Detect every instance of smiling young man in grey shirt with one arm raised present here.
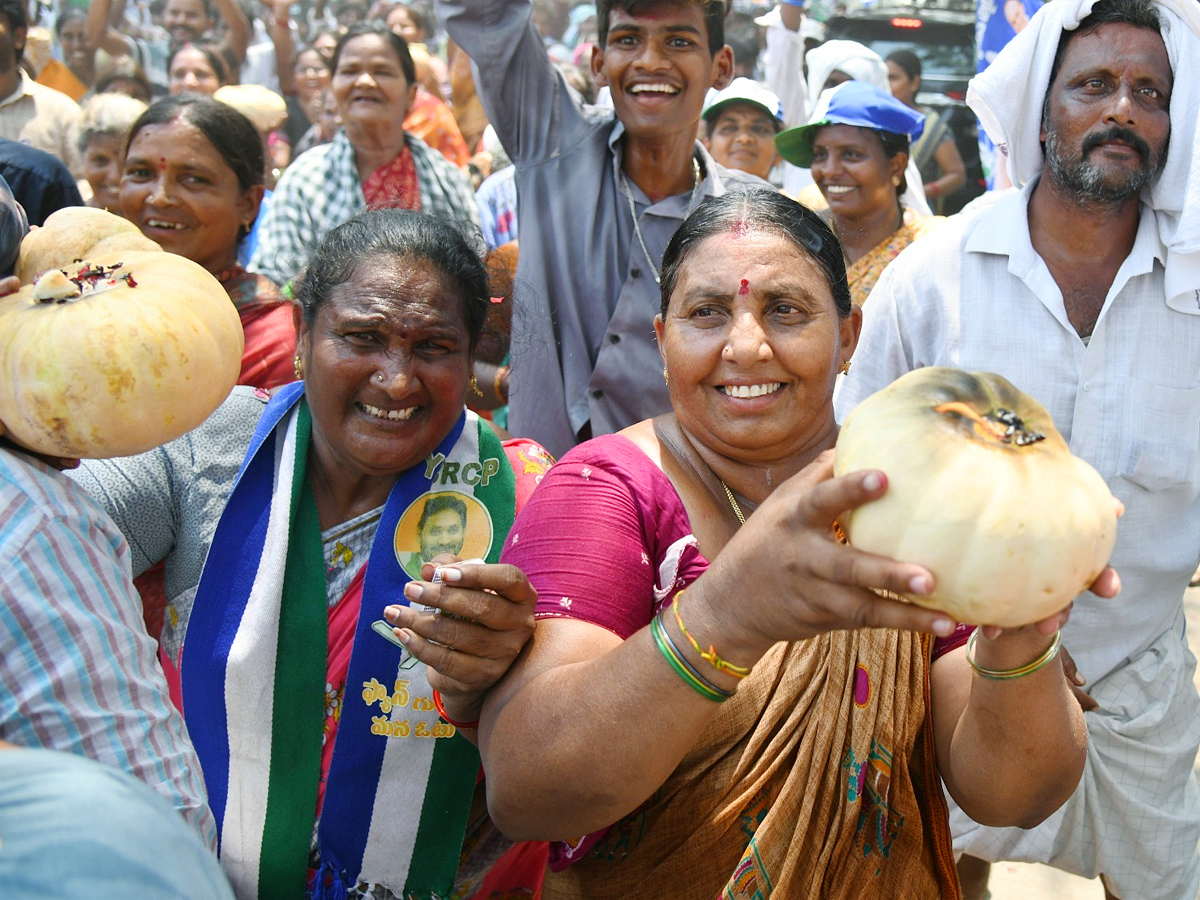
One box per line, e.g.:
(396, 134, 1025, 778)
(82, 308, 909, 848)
(439, 0, 762, 455)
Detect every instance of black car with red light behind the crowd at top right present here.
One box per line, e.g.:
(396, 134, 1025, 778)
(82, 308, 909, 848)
(826, 0, 984, 215)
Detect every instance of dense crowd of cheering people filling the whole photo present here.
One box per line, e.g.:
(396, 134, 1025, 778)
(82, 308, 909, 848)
(0, 0, 1200, 900)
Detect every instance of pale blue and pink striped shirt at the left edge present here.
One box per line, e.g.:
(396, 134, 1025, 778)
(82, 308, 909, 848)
(0, 448, 216, 847)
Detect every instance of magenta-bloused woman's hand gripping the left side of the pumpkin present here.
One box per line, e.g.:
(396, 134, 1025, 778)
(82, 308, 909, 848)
(689, 450, 955, 659)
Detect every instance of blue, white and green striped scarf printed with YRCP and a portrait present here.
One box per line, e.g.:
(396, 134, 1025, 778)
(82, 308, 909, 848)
(182, 383, 516, 900)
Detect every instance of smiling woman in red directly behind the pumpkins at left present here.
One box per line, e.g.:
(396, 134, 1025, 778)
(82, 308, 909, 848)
(120, 95, 295, 388)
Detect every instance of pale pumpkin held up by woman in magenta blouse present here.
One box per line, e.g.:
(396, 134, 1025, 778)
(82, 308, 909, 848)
(834, 367, 1117, 626)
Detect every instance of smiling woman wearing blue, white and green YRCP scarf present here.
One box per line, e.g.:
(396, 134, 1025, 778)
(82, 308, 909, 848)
(70, 211, 548, 900)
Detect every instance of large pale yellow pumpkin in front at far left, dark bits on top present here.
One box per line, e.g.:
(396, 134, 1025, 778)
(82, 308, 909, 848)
(0, 251, 244, 457)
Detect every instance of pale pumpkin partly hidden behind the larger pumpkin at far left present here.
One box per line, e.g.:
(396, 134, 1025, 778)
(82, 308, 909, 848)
(14, 206, 162, 284)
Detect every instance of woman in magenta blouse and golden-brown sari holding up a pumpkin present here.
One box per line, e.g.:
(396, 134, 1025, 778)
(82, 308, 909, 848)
(480, 191, 1115, 899)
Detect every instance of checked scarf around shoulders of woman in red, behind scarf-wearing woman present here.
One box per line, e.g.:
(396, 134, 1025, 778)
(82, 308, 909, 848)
(247, 131, 479, 284)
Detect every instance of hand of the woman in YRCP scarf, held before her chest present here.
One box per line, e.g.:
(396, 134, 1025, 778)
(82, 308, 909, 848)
(384, 557, 538, 719)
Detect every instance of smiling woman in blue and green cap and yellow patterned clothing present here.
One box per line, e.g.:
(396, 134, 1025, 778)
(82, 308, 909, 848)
(775, 82, 942, 306)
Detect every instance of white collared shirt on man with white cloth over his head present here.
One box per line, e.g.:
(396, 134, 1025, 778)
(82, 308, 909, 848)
(836, 182, 1200, 680)
